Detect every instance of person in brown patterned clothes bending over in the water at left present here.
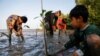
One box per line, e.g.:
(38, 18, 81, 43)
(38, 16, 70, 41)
(7, 15, 27, 44)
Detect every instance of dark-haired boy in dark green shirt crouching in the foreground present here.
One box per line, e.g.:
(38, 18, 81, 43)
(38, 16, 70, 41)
(52, 5, 100, 56)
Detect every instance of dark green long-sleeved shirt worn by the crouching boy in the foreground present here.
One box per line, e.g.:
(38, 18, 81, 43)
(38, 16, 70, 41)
(65, 25, 100, 56)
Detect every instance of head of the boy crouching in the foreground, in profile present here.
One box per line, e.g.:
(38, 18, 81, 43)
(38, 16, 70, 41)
(69, 5, 89, 28)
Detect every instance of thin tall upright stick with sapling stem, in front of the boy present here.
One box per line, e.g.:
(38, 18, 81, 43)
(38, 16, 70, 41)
(41, 0, 48, 56)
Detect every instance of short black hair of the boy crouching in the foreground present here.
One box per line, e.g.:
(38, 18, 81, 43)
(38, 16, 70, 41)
(69, 5, 89, 22)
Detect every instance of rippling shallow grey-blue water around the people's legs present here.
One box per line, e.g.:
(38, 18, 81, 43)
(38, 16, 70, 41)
(0, 30, 70, 56)
